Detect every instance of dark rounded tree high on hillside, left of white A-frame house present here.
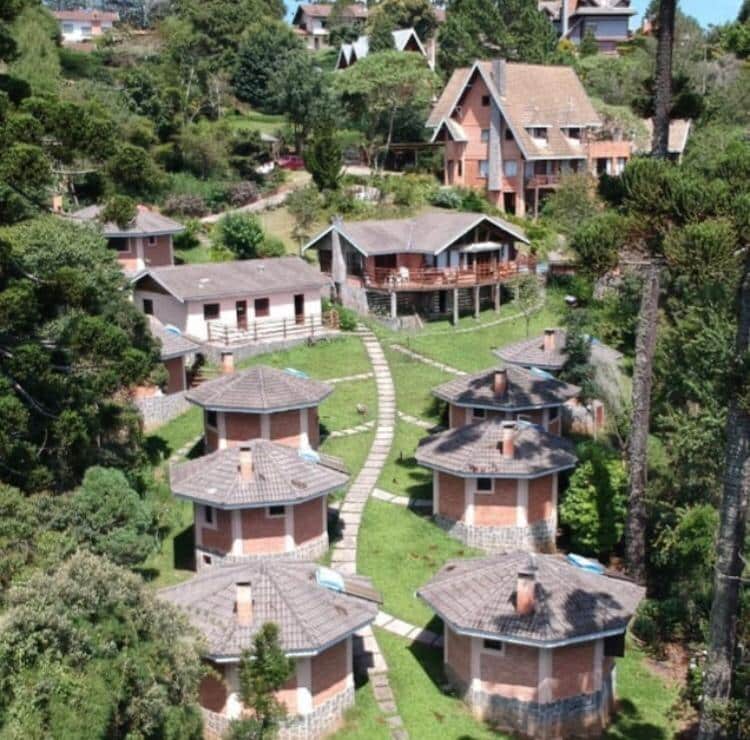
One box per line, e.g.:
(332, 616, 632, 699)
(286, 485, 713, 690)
(232, 22, 303, 113)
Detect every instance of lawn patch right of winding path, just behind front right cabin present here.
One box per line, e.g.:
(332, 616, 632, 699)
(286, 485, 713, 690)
(357, 499, 478, 625)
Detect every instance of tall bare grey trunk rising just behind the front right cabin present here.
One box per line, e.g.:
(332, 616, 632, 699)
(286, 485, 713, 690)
(625, 263, 660, 584)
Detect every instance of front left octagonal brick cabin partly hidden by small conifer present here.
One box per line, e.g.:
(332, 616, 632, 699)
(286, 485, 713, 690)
(159, 560, 379, 740)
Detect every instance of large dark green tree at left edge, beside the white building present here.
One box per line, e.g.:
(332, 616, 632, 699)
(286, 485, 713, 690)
(0, 217, 158, 491)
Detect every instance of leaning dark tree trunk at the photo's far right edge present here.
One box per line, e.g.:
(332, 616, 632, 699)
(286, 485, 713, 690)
(698, 254, 750, 740)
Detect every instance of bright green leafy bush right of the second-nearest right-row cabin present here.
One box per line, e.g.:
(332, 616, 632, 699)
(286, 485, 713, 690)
(560, 442, 628, 558)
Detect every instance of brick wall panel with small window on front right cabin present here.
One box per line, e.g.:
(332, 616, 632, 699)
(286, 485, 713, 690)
(479, 643, 539, 701)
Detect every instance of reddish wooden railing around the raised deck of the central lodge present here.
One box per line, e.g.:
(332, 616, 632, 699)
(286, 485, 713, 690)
(364, 256, 536, 291)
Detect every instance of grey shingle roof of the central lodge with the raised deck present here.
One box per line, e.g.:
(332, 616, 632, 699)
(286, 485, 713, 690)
(305, 211, 528, 255)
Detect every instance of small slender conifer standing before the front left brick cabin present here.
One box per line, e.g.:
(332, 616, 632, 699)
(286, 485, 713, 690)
(229, 622, 295, 740)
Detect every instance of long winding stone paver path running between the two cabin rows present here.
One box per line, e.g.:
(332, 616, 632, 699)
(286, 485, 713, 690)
(331, 327, 409, 740)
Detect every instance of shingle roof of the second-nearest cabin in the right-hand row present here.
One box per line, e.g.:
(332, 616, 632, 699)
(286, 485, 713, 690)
(415, 419, 577, 478)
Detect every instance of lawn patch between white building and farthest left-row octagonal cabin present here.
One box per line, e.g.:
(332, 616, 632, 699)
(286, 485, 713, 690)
(237, 336, 372, 380)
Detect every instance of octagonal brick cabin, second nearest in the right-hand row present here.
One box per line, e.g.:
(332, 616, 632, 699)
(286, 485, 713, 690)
(415, 419, 576, 551)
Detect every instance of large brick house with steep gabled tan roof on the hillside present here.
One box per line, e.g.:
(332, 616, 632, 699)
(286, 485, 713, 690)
(427, 59, 632, 216)
